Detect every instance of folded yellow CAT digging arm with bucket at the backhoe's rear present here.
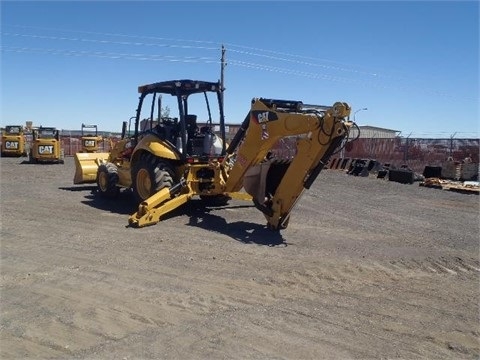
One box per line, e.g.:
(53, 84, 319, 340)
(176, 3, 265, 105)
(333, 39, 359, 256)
(224, 98, 352, 230)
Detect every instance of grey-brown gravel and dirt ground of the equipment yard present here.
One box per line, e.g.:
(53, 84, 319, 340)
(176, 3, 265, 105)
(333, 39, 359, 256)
(0, 158, 480, 360)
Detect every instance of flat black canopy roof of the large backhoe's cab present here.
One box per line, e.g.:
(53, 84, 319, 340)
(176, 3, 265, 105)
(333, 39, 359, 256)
(138, 79, 220, 95)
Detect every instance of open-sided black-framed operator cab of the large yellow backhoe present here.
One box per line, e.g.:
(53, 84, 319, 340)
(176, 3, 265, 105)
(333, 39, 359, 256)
(136, 80, 225, 159)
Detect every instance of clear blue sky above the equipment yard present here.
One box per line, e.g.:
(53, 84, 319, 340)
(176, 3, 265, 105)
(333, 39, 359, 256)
(0, 1, 479, 138)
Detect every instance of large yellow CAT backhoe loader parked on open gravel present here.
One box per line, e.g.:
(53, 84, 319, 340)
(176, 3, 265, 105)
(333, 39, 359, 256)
(75, 80, 353, 230)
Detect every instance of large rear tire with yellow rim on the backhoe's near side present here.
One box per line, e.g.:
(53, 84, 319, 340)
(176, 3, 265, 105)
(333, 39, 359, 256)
(132, 153, 175, 204)
